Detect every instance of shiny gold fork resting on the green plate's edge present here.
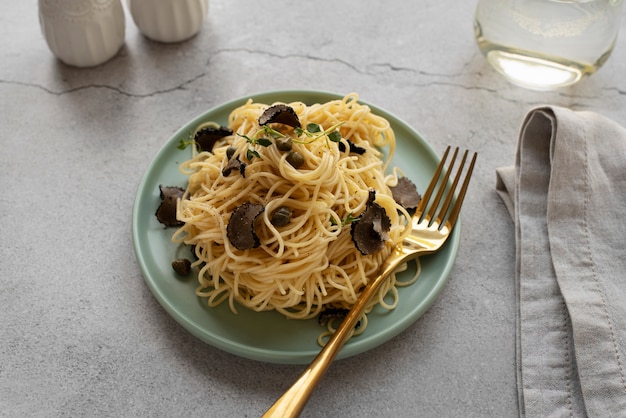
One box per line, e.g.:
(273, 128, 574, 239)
(263, 146, 476, 418)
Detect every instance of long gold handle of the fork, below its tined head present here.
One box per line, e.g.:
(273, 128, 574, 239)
(263, 257, 399, 418)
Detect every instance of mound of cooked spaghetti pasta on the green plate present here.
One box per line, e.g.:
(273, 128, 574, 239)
(173, 94, 418, 338)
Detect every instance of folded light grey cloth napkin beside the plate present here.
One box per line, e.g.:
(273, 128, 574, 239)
(496, 106, 626, 417)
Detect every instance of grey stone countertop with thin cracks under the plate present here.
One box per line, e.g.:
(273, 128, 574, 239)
(0, 0, 626, 417)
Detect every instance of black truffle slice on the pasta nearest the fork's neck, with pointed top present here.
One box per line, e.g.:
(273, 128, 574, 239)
(350, 192, 391, 255)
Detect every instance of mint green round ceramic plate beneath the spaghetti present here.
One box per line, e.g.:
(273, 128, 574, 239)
(132, 91, 460, 364)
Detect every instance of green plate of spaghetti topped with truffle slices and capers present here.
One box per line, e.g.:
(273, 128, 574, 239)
(132, 91, 460, 364)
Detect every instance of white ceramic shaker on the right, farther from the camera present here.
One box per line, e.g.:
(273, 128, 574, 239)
(128, 0, 209, 42)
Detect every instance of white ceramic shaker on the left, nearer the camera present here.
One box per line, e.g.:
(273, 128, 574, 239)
(39, 0, 126, 67)
